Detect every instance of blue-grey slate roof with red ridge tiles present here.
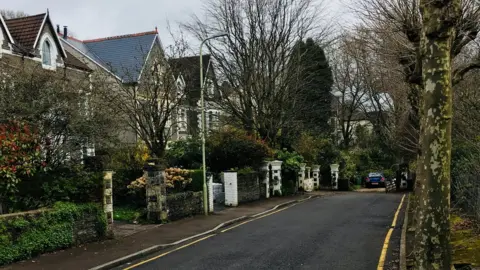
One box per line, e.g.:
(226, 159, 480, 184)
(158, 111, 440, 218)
(62, 31, 159, 83)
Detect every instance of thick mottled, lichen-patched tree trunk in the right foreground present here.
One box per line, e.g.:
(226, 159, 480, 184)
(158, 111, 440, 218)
(415, 0, 461, 270)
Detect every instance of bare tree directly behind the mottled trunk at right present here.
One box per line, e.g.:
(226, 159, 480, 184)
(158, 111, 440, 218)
(355, 0, 480, 154)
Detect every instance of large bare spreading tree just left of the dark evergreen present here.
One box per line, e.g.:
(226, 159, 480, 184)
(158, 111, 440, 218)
(185, 0, 334, 144)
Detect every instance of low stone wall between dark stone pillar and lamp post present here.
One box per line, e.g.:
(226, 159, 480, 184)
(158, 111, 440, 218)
(167, 191, 203, 221)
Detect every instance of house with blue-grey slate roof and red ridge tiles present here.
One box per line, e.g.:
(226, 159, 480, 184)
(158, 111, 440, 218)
(57, 28, 188, 146)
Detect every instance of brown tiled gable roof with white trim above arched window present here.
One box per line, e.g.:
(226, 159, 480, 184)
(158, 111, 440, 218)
(5, 13, 67, 58)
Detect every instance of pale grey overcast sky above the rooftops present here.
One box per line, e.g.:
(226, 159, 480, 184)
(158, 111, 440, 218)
(0, 0, 352, 47)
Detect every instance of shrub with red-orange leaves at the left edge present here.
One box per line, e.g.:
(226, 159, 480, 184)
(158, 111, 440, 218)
(0, 121, 42, 195)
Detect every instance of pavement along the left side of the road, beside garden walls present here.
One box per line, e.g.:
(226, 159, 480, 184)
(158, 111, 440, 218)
(1, 192, 334, 270)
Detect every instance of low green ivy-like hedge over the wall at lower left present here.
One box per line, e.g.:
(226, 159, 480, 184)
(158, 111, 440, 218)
(0, 203, 107, 265)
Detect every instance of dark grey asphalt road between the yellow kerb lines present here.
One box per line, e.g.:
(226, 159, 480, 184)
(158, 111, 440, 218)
(123, 193, 402, 270)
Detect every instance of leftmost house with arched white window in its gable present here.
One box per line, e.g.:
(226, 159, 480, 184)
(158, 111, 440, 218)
(0, 12, 94, 160)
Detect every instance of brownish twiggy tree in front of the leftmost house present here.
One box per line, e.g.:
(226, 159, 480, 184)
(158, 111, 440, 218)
(0, 61, 116, 167)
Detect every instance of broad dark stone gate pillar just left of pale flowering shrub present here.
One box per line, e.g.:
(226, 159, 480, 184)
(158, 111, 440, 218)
(144, 163, 168, 222)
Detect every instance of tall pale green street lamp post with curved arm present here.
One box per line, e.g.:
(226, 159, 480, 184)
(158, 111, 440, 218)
(200, 33, 227, 216)
